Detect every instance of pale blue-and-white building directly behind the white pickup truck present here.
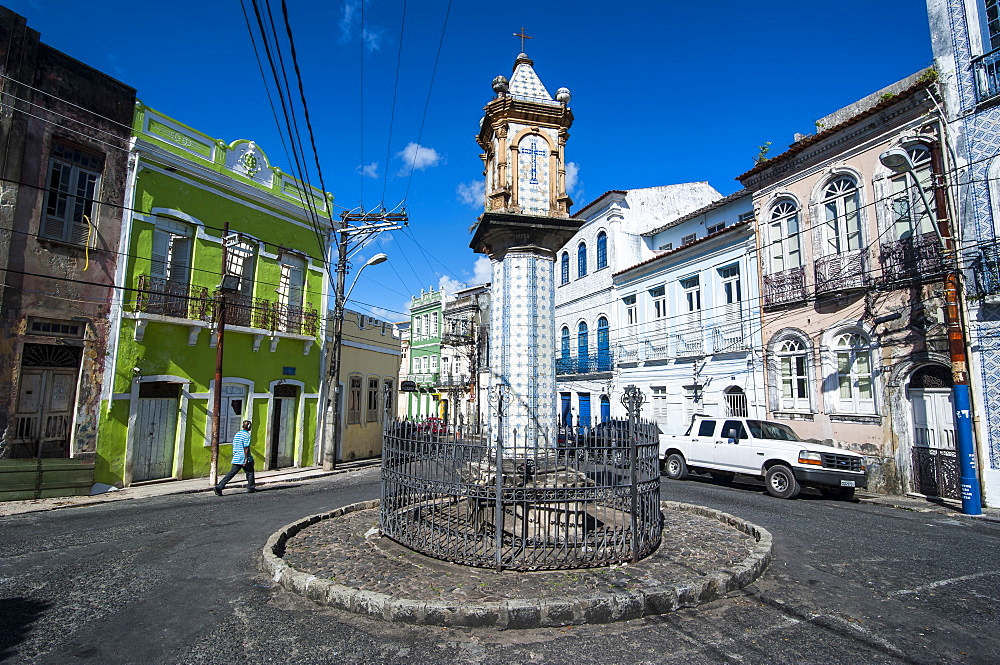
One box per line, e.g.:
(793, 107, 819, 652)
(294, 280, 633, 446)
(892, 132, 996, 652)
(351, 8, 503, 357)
(613, 190, 766, 434)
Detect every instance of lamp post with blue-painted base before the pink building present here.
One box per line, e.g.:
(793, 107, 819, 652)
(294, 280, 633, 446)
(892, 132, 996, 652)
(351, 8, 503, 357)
(879, 144, 983, 515)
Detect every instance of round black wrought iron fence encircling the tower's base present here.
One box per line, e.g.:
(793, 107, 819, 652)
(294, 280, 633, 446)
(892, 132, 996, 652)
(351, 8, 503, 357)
(380, 387, 663, 570)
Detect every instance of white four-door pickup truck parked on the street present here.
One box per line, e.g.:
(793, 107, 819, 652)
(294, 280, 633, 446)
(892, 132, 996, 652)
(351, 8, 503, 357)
(660, 416, 868, 499)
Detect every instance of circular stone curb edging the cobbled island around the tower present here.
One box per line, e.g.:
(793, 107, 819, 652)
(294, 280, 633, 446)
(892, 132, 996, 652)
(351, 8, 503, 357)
(263, 499, 772, 629)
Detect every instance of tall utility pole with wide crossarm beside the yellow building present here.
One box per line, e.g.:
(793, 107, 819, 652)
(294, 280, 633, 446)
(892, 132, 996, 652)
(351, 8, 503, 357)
(323, 209, 408, 471)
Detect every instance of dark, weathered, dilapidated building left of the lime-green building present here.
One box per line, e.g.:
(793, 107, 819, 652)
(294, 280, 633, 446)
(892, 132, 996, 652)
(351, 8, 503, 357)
(0, 7, 135, 498)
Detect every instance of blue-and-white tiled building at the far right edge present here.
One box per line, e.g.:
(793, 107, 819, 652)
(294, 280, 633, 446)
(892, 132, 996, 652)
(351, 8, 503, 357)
(927, 0, 1000, 506)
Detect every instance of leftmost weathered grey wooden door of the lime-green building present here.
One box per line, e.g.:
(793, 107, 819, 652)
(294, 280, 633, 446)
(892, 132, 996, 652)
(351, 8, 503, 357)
(132, 397, 178, 482)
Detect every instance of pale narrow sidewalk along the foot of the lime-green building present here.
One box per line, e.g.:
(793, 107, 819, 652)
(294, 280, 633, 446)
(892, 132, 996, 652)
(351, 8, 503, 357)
(0, 458, 382, 517)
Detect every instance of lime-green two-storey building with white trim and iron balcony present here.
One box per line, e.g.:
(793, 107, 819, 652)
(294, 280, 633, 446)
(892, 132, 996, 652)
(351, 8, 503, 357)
(95, 103, 332, 486)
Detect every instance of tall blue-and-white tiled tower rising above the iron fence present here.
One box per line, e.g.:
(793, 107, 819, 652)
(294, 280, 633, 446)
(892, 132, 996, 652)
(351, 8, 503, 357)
(471, 53, 582, 446)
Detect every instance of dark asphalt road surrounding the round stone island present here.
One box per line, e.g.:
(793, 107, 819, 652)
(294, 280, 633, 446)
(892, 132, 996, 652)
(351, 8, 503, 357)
(0, 468, 1000, 665)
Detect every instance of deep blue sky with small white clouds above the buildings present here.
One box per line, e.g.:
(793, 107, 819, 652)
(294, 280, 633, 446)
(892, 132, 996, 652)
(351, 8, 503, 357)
(0, 0, 932, 320)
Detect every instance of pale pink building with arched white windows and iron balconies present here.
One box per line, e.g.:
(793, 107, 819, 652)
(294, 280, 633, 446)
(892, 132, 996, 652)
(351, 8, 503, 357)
(739, 71, 957, 495)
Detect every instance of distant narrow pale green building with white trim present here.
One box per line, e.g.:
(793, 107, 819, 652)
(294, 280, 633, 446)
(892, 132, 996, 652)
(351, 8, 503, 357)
(406, 291, 444, 418)
